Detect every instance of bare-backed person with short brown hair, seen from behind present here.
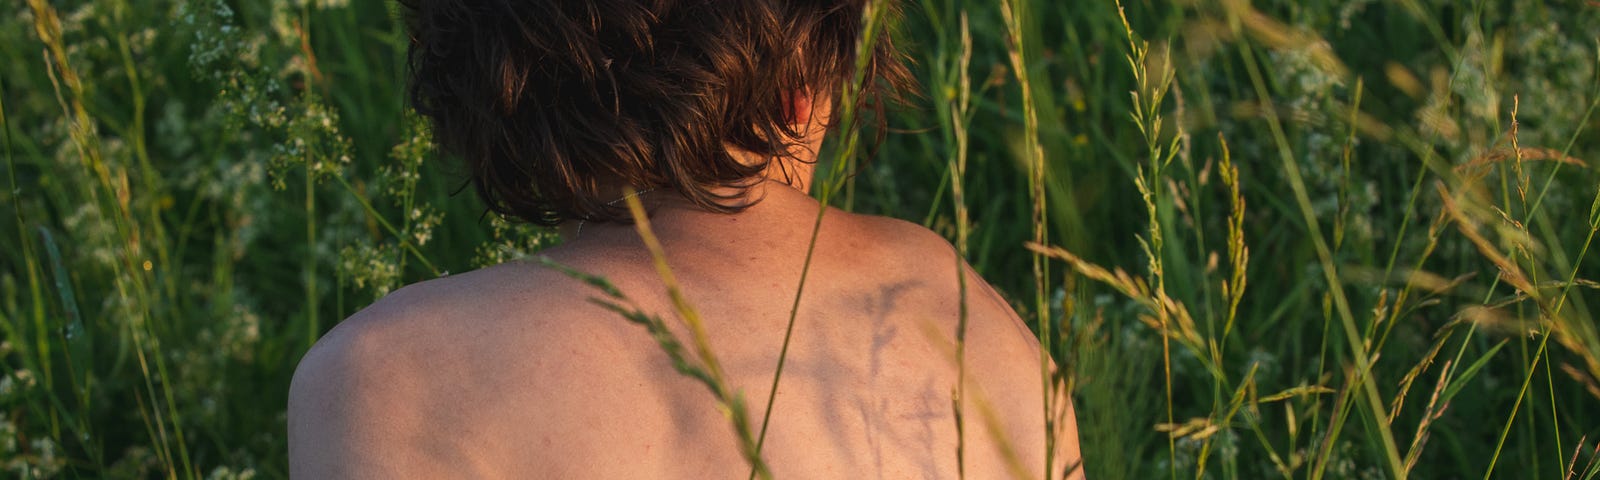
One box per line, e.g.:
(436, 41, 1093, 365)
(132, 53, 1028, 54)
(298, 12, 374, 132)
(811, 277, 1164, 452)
(290, 0, 1077, 478)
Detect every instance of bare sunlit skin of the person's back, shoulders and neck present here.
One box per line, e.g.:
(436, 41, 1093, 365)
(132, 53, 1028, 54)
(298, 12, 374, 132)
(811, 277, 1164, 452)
(288, 98, 1078, 478)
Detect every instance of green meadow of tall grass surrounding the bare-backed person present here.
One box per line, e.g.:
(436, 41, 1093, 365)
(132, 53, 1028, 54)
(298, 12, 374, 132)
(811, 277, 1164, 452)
(0, 0, 1600, 478)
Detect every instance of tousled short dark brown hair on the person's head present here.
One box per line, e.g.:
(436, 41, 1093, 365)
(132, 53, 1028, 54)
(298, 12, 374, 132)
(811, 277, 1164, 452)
(400, 0, 909, 226)
